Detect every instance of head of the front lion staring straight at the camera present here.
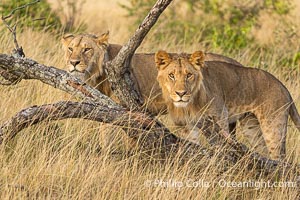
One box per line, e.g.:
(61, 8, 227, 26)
(155, 51, 204, 107)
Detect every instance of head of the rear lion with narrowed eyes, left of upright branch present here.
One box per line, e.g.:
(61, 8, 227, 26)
(62, 33, 108, 82)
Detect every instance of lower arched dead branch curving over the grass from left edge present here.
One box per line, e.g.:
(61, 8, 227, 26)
(0, 101, 213, 158)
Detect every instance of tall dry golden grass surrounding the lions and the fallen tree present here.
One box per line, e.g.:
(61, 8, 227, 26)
(0, 0, 300, 199)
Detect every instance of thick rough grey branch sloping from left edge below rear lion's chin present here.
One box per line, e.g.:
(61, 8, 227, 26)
(0, 54, 121, 107)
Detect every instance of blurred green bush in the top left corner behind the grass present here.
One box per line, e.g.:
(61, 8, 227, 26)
(0, 0, 86, 33)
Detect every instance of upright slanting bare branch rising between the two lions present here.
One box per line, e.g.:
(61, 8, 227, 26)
(106, 0, 172, 109)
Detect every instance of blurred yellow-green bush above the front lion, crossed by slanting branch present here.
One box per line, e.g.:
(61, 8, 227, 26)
(123, 0, 291, 50)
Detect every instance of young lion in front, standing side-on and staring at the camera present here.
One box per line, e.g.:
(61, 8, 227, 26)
(155, 51, 300, 159)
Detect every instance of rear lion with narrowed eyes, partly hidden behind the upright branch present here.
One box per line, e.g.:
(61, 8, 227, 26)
(62, 32, 240, 114)
